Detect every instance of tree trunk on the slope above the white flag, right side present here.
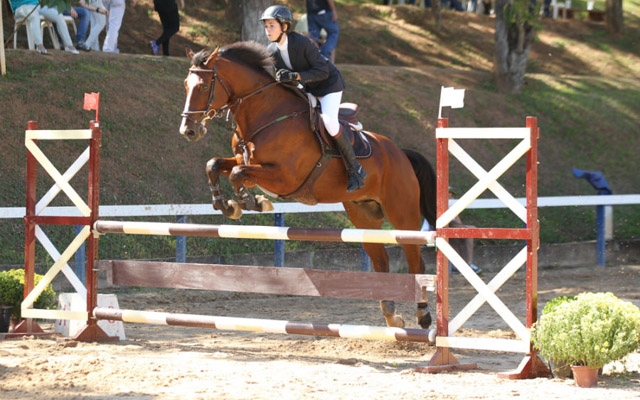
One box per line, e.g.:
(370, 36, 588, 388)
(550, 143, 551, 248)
(493, 0, 533, 94)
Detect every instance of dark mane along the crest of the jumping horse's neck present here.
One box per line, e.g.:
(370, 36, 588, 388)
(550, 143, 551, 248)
(191, 41, 275, 75)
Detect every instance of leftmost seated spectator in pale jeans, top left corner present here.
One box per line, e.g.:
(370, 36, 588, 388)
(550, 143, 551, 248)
(9, 0, 80, 54)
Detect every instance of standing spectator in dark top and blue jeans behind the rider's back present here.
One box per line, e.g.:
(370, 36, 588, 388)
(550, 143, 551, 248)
(307, 0, 340, 61)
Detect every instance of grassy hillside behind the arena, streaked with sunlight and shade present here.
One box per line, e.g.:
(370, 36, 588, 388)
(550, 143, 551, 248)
(0, 0, 640, 263)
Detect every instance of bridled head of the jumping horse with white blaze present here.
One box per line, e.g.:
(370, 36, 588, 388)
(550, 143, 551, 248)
(180, 48, 230, 141)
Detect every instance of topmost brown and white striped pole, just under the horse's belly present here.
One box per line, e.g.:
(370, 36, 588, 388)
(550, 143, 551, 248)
(93, 220, 436, 246)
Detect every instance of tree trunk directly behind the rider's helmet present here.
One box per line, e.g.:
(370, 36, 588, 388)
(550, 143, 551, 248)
(225, 0, 273, 45)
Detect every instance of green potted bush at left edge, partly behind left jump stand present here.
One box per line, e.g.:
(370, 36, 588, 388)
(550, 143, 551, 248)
(0, 268, 56, 328)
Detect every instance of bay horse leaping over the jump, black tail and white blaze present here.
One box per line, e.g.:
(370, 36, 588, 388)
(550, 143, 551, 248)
(180, 42, 436, 329)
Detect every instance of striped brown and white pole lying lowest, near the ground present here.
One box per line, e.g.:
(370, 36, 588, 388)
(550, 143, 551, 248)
(93, 307, 435, 343)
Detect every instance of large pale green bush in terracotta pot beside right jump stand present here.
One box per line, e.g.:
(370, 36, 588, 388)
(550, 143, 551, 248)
(531, 293, 640, 387)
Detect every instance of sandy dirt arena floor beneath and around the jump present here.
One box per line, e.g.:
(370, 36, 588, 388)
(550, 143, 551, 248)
(0, 265, 640, 399)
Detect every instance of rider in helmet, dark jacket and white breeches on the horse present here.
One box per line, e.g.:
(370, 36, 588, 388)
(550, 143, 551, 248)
(260, 5, 367, 192)
